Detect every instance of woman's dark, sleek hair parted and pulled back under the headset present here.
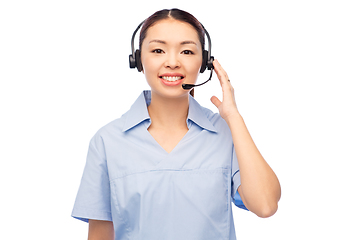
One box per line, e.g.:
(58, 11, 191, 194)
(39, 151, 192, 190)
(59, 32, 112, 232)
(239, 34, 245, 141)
(139, 8, 205, 96)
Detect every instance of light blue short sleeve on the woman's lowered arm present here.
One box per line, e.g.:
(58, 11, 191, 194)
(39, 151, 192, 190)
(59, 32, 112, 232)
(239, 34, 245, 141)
(72, 134, 112, 222)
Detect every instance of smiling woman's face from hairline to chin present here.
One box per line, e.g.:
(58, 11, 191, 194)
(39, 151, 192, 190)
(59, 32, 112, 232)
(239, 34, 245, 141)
(141, 19, 202, 98)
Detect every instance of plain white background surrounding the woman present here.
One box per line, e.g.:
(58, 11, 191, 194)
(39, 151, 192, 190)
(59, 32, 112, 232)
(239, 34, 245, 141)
(0, 0, 348, 240)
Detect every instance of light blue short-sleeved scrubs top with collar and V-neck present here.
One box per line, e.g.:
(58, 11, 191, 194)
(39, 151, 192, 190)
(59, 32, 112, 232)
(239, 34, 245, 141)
(72, 91, 245, 240)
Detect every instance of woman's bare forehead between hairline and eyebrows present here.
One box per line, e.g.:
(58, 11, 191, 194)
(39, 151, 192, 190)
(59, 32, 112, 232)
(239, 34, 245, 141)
(144, 19, 200, 45)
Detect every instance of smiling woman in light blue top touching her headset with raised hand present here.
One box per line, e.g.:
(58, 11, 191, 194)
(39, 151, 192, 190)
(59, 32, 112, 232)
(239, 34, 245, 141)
(72, 9, 280, 240)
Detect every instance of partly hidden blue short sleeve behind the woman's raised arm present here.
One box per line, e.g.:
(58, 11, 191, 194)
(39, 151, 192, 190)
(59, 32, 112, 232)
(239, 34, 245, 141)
(232, 145, 248, 210)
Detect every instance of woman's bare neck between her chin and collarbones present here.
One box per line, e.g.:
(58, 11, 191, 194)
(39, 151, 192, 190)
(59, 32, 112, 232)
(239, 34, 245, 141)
(148, 93, 189, 129)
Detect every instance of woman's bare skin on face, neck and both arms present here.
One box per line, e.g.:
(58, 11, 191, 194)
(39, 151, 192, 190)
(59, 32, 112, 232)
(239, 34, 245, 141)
(88, 18, 281, 240)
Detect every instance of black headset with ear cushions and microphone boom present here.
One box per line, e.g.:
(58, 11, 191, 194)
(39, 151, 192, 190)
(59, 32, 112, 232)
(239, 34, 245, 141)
(129, 20, 214, 90)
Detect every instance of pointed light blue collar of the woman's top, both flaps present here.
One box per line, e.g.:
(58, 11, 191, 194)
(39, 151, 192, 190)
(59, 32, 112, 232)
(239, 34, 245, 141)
(122, 90, 217, 132)
